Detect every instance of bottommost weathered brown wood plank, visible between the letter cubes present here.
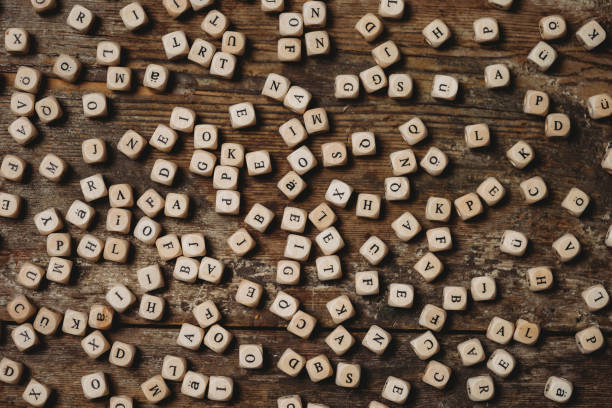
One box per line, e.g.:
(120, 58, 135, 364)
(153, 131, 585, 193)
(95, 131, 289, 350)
(0, 327, 612, 408)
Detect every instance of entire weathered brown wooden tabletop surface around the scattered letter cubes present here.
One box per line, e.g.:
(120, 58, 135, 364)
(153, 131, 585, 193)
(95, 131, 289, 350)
(0, 0, 612, 407)
